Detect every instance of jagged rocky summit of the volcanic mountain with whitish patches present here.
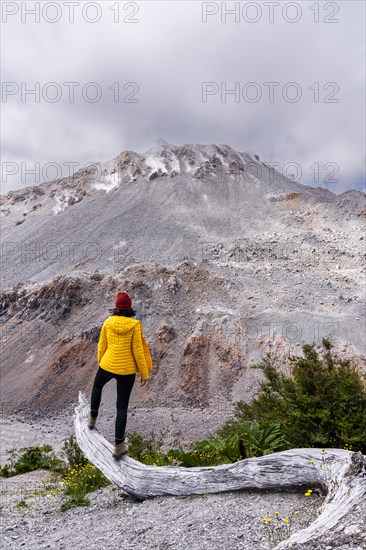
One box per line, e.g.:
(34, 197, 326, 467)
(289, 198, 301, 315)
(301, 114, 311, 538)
(0, 138, 330, 209)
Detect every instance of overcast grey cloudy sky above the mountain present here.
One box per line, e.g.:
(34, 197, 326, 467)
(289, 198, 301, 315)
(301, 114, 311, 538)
(1, 0, 365, 193)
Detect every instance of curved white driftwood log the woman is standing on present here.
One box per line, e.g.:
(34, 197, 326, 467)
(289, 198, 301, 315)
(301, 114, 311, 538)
(74, 392, 366, 550)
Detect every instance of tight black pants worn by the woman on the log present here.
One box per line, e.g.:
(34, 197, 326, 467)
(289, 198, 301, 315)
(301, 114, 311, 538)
(90, 367, 136, 445)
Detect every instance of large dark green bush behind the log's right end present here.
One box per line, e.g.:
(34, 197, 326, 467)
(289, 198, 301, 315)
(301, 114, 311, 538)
(217, 339, 366, 454)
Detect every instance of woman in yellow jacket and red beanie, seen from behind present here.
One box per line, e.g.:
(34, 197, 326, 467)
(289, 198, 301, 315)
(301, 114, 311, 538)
(88, 292, 152, 458)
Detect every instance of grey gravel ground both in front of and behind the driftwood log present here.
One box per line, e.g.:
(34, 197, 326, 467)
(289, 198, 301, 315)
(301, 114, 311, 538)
(0, 416, 366, 550)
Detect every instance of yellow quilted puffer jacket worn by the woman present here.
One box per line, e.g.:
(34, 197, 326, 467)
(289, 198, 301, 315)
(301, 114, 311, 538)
(98, 315, 152, 380)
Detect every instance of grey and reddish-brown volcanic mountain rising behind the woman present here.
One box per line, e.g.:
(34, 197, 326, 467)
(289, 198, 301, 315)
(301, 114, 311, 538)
(0, 140, 366, 436)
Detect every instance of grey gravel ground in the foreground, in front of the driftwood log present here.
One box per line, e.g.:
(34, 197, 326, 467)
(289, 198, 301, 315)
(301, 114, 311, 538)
(1, 472, 323, 550)
